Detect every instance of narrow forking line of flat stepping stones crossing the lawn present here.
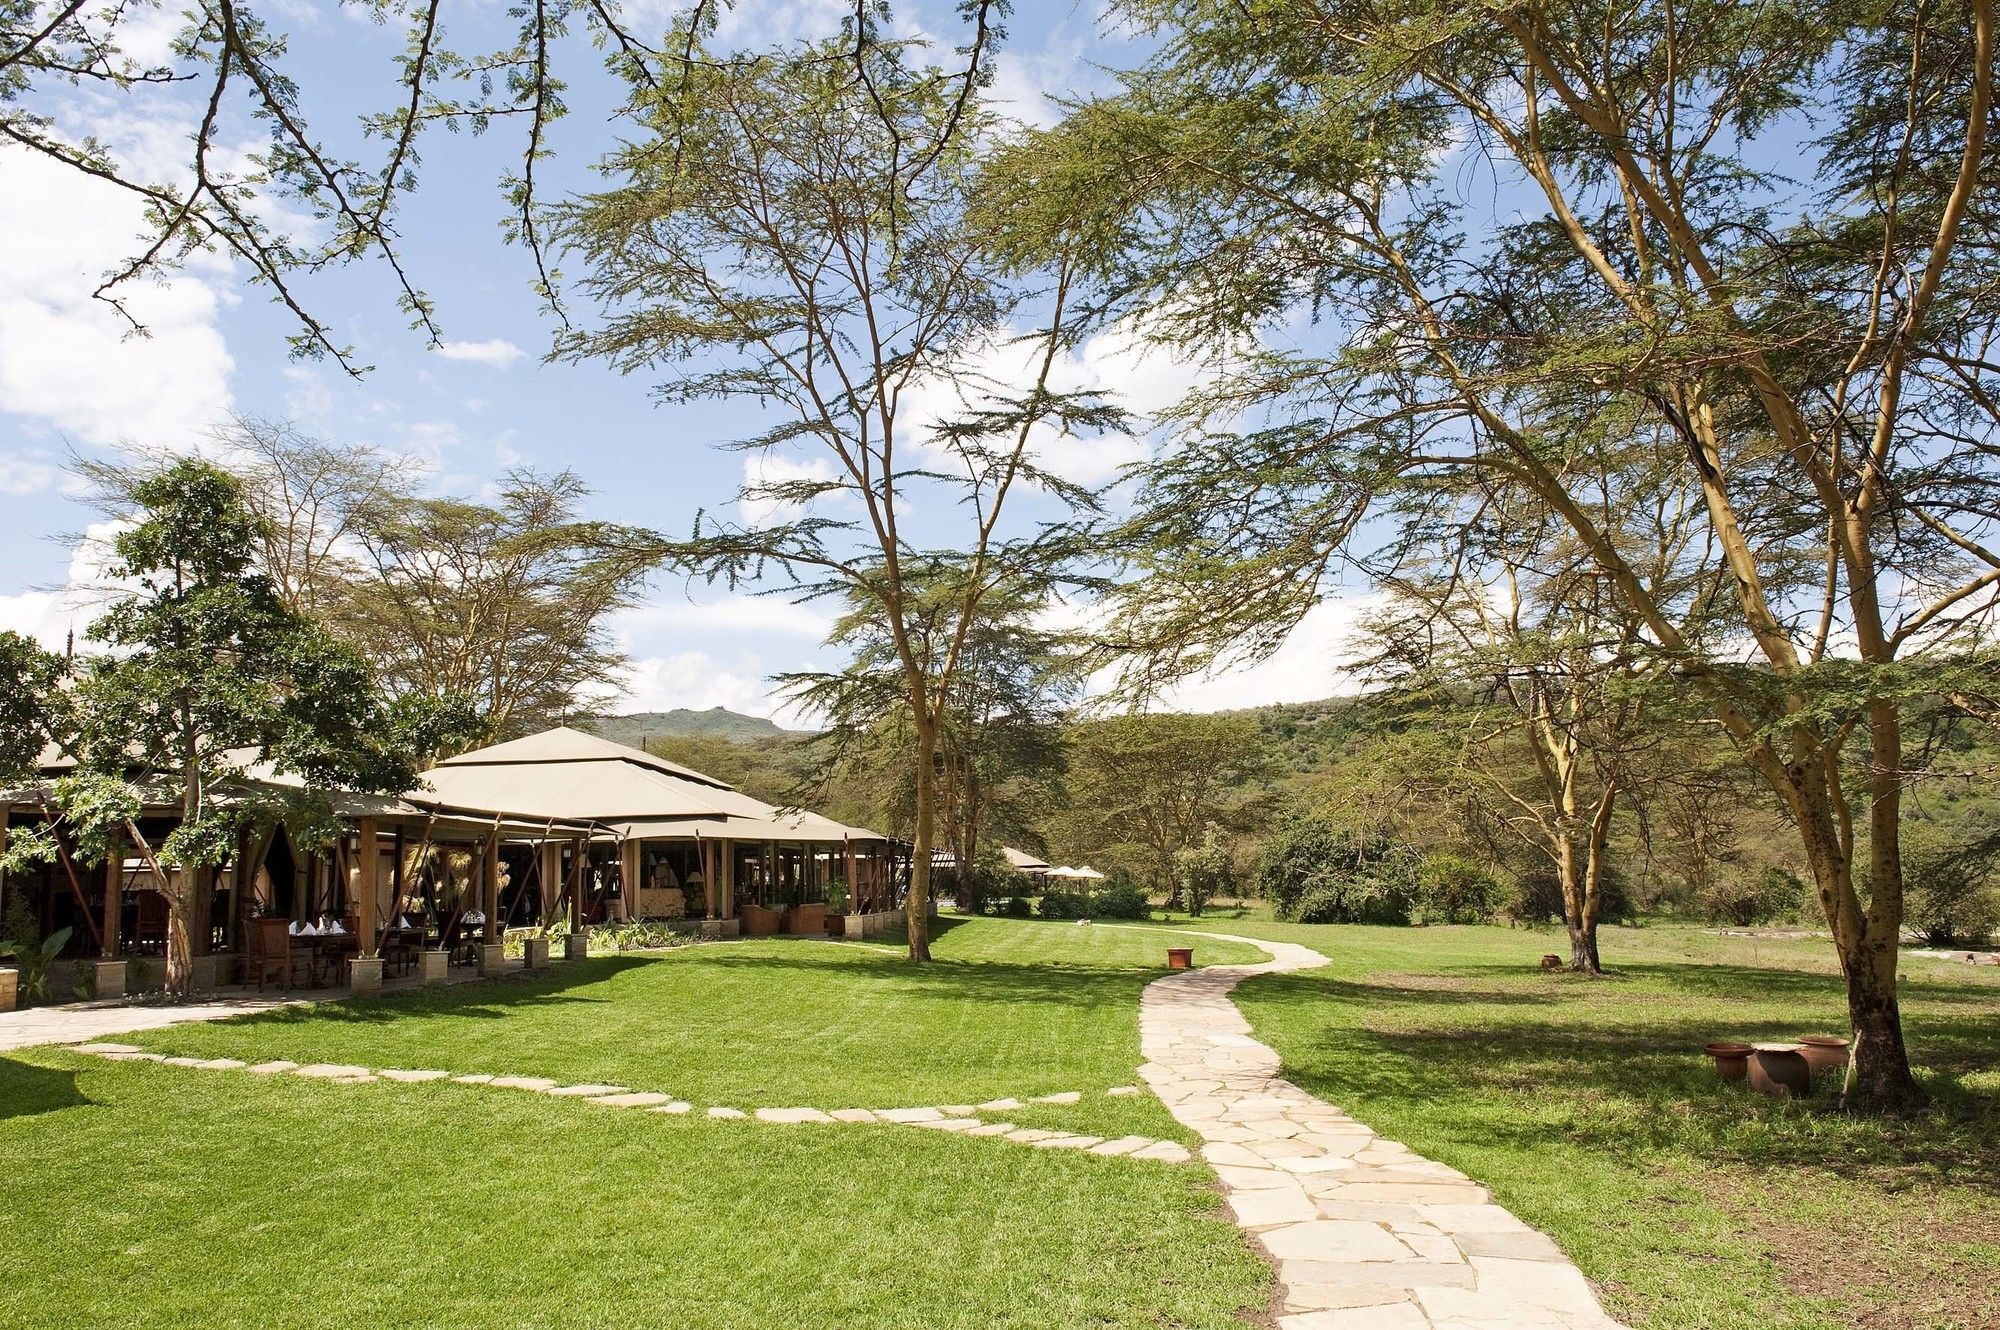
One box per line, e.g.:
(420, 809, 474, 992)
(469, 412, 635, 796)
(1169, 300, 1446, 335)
(76, 1040, 1192, 1164)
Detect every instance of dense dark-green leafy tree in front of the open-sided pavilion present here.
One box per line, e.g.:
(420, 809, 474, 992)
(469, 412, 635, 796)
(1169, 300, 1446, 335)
(68, 460, 466, 994)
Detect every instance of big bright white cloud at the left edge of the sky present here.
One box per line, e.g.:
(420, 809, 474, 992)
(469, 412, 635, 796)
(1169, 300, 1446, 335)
(0, 150, 234, 446)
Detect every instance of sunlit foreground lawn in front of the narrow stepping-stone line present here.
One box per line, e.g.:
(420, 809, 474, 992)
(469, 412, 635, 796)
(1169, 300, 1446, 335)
(0, 1050, 1268, 1330)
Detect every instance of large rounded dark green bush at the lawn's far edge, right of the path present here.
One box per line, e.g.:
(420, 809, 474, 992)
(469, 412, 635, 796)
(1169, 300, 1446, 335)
(1256, 814, 1418, 924)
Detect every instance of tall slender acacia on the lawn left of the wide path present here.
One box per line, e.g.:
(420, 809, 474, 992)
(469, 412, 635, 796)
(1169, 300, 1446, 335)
(560, 26, 1116, 960)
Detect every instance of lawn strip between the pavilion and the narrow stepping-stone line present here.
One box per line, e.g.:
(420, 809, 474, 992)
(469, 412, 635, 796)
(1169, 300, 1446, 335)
(121, 920, 1264, 1140)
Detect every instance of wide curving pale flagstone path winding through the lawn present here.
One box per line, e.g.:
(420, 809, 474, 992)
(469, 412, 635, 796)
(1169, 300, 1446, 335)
(1138, 932, 1618, 1330)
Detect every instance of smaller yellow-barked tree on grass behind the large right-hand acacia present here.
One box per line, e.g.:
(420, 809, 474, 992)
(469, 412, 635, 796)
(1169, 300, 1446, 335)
(1364, 462, 1700, 974)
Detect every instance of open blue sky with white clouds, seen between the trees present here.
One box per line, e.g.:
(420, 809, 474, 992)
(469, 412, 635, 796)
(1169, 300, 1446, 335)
(0, 0, 1376, 718)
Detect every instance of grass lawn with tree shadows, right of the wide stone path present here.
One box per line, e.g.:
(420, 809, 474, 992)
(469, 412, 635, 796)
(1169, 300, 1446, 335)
(1152, 918, 2000, 1330)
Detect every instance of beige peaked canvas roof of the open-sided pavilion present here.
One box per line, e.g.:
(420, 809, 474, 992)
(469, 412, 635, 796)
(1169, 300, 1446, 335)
(424, 726, 880, 840)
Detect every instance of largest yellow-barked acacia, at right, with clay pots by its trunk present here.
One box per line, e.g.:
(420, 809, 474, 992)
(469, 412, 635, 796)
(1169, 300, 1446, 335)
(1000, 0, 2000, 1102)
